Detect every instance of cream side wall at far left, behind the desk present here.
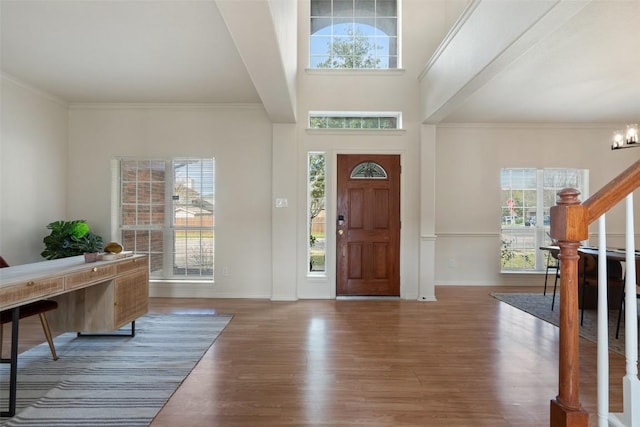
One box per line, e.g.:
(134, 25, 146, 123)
(0, 76, 67, 265)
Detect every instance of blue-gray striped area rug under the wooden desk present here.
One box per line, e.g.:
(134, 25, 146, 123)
(0, 314, 231, 427)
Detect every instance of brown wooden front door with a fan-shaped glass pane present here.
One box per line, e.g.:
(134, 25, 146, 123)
(336, 154, 400, 296)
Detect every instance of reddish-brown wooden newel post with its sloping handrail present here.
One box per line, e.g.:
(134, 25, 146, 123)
(550, 161, 640, 427)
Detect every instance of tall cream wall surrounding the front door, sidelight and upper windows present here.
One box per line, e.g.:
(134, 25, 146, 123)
(297, 0, 466, 299)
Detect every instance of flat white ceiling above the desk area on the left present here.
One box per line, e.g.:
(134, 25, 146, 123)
(0, 0, 260, 103)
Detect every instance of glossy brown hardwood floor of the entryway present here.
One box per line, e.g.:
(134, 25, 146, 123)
(5, 287, 624, 427)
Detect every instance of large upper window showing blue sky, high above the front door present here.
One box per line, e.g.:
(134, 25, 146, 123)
(309, 0, 398, 69)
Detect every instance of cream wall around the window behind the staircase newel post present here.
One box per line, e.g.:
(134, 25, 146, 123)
(435, 124, 640, 285)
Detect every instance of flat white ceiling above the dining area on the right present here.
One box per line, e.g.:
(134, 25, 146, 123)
(445, 0, 640, 123)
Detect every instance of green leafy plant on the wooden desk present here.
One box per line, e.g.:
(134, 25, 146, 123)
(40, 220, 104, 259)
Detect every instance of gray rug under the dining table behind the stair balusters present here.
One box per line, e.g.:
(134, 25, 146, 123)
(491, 293, 624, 355)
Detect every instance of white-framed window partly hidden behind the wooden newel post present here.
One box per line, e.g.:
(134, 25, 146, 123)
(500, 168, 589, 272)
